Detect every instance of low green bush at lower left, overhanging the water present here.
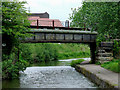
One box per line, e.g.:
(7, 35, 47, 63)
(2, 59, 29, 79)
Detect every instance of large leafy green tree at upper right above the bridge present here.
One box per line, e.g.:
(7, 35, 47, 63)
(70, 2, 120, 41)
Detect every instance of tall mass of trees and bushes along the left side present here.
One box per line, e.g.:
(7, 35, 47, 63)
(2, 0, 30, 79)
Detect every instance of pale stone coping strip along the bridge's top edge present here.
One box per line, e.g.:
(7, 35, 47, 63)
(29, 29, 98, 35)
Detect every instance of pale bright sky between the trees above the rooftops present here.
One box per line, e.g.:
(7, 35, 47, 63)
(19, 0, 82, 21)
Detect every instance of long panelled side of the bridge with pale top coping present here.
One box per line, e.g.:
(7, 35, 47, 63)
(21, 29, 97, 43)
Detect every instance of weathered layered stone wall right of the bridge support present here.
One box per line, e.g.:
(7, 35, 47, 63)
(96, 42, 113, 63)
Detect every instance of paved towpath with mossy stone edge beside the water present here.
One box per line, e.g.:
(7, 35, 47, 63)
(75, 64, 118, 89)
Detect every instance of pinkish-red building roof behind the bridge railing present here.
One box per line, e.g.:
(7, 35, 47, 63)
(28, 16, 63, 27)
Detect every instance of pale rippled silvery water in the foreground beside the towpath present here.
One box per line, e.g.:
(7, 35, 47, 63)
(20, 66, 96, 88)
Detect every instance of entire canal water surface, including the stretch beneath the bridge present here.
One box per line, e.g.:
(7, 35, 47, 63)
(2, 58, 97, 88)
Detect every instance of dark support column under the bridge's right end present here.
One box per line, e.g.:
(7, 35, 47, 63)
(90, 42, 96, 64)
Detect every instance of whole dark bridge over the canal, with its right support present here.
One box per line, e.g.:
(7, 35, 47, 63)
(21, 20, 97, 63)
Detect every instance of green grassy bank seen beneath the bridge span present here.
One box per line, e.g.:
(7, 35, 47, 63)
(22, 43, 90, 62)
